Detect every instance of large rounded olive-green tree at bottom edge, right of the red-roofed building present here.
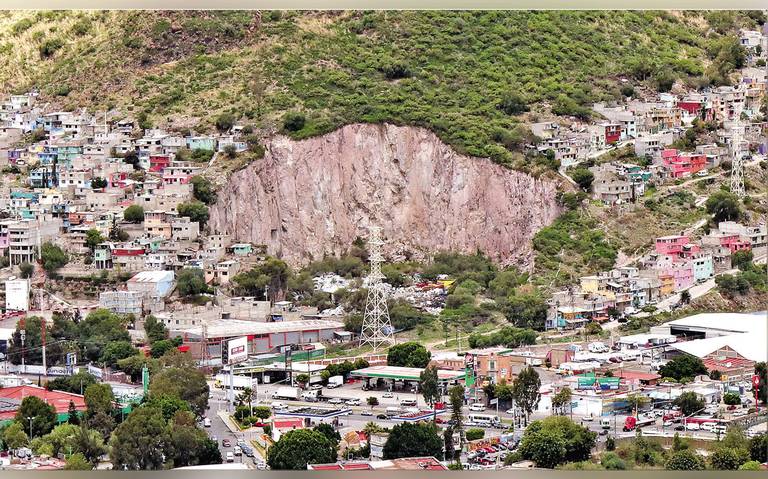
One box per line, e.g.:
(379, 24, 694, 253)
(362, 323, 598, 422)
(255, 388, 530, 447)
(109, 407, 171, 471)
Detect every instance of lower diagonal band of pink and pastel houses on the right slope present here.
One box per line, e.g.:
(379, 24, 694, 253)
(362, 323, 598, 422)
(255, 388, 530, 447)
(546, 221, 768, 329)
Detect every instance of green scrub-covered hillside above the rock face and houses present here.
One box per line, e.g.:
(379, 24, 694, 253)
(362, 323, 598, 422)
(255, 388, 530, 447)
(0, 11, 754, 170)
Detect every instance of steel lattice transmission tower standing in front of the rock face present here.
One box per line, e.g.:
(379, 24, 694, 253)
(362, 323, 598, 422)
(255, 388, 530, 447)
(360, 226, 395, 351)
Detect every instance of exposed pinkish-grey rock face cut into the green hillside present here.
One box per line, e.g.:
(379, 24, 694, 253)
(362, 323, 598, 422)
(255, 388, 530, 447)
(210, 124, 560, 266)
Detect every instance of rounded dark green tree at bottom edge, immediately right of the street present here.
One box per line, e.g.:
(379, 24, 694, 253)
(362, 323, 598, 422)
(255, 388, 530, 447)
(267, 429, 336, 471)
